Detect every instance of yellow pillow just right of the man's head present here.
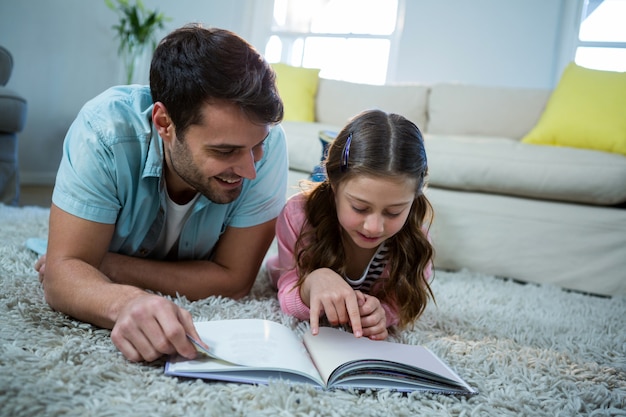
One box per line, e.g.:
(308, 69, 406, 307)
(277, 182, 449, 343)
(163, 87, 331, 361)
(272, 63, 320, 122)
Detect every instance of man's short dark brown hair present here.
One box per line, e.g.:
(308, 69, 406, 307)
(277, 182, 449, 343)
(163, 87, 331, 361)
(150, 24, 283, 137)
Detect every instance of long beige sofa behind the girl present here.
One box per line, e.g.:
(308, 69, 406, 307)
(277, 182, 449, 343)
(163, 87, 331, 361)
(283, 79, 626, 295)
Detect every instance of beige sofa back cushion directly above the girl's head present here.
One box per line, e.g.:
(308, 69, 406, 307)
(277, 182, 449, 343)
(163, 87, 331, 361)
(315, 78, 429, 130)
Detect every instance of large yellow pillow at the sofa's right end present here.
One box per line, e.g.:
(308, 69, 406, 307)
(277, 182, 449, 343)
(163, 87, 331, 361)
(522, 62, 626, 155)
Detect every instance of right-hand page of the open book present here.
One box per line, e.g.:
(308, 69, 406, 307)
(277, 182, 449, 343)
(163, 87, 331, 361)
(304, 327, 472, 391)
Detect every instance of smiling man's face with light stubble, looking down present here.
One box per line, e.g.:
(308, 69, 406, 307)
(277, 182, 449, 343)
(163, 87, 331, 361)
(164, 101, 269, 204)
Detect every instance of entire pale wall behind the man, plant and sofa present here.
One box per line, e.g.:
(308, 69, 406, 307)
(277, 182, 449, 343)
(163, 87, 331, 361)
(0, 0, 580, 183)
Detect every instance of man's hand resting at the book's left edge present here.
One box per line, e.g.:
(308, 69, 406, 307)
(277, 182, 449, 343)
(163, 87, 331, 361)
(111, 294, 200, 362)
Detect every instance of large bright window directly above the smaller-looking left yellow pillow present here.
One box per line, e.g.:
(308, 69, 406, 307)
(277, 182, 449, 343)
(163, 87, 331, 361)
(265, 0, 404, 84)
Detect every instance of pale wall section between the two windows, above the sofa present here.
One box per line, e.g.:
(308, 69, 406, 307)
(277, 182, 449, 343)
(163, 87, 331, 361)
(395, 0, 576, 88)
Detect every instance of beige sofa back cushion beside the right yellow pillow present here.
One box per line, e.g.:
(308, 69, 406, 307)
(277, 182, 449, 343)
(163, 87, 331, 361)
(426, 84, 551, 139)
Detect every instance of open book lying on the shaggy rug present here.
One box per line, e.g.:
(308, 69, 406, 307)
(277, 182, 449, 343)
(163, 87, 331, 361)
(165, 319, 476, 395)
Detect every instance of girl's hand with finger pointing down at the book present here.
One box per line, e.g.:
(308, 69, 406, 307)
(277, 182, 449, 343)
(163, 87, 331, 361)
(300, 268, 363, 337)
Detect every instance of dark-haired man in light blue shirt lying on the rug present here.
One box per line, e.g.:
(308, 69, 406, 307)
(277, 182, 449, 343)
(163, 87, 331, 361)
(36, 25, 287, 361)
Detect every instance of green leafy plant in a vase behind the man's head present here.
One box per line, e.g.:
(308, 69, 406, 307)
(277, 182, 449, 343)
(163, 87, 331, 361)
(104, 0, 171, 84)
